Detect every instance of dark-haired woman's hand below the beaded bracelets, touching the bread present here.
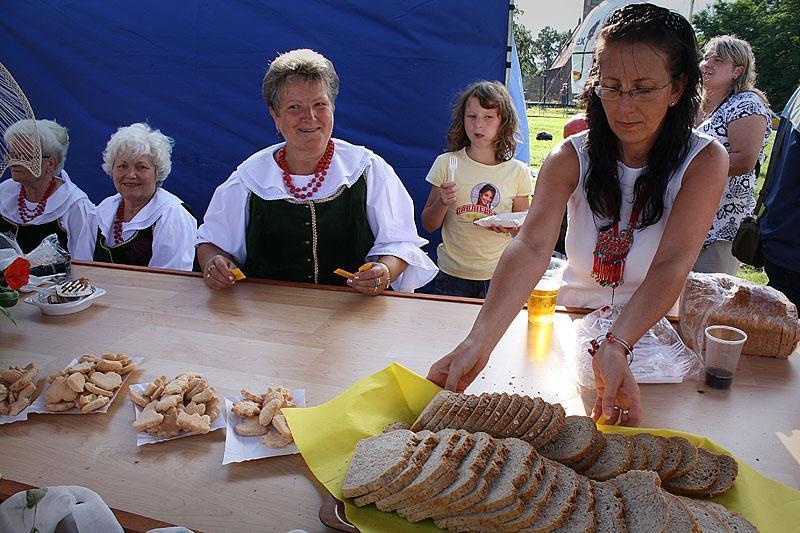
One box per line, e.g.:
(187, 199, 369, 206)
(592, 342, 642, 426)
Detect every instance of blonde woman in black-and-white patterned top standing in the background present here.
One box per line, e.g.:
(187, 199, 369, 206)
(693, 35, 772, 275)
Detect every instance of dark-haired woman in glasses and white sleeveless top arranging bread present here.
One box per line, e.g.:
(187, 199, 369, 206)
(428, 4, 728, 425)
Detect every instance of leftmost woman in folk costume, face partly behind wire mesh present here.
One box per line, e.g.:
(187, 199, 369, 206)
(0, 120, 94, 259)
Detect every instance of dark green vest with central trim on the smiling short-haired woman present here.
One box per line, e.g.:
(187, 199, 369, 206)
(242, 175, 375, 285)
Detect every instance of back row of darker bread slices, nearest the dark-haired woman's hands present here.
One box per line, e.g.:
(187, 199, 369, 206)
(411, 391, 738, 496)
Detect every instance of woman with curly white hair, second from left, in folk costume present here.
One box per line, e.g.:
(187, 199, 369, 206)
(94, 123, 197, 270)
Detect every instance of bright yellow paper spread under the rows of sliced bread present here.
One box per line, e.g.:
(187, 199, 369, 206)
(283, 363, 800, 533)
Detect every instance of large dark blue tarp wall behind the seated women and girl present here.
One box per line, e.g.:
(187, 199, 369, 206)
(0, 0, 529, 254)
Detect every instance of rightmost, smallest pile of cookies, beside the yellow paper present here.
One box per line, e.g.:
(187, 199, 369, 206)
(231, 387, 295, 448)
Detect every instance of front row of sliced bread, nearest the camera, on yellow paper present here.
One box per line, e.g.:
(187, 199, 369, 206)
(342, 429, 756, 533)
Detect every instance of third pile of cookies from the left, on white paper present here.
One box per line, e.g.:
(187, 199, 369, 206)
(128, 372, 219, 438)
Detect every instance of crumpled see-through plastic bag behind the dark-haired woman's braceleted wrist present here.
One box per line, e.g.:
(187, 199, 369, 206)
(575, 305, 702, 389)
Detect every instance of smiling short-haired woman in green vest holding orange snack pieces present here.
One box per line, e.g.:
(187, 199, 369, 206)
(197, 50, 437, 295)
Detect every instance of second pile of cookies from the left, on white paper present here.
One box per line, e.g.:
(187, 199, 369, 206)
(44, 353, 136, 414)
